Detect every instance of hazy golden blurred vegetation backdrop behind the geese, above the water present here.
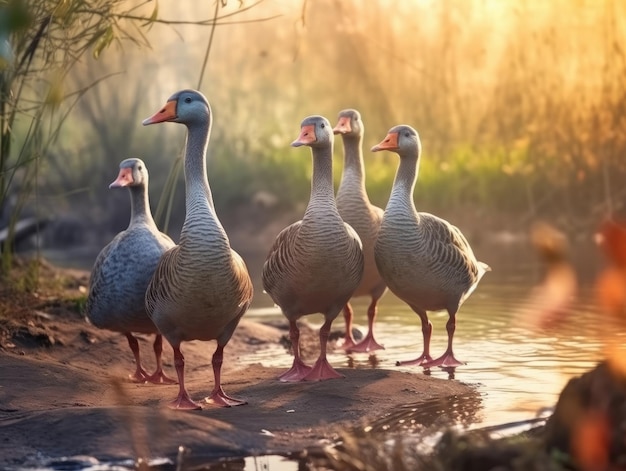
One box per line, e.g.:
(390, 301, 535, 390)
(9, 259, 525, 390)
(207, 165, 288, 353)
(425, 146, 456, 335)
(0, 0, 626, 280)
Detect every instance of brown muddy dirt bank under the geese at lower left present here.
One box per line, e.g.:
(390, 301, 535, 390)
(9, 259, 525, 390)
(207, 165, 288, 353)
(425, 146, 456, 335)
(0, 265, 470, 468)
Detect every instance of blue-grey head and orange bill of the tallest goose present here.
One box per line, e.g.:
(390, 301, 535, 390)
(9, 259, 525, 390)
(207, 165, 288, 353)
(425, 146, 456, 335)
(142, 90, 211, 126)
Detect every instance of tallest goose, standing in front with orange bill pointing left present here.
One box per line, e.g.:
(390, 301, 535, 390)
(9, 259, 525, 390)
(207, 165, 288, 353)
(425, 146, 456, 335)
(143, 90, 253, 409)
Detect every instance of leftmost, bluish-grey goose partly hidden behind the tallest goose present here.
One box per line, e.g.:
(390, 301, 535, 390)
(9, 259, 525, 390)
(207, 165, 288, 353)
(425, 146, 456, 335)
(85, 159, 176, 384)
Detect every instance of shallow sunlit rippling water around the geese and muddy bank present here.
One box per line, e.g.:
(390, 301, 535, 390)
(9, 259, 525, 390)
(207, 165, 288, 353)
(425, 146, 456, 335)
(28, 242, 626, 471)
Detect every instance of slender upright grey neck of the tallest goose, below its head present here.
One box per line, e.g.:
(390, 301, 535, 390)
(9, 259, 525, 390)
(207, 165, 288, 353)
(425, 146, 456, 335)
(185, 122, 215, 214)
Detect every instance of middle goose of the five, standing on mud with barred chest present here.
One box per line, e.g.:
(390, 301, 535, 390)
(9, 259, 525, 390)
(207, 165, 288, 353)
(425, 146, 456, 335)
(262, 116, 363, 381)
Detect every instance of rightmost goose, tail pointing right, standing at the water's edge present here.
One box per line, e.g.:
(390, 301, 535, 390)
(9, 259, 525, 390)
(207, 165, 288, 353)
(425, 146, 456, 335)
(372, 125, 491, 368)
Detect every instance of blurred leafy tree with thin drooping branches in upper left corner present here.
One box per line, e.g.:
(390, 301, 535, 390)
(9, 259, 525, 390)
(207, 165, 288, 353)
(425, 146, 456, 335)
(0, 0, 266, 278)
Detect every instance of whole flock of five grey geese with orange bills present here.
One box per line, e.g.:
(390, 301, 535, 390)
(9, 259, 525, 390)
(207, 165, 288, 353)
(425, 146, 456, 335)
(85, 90, 489, 409)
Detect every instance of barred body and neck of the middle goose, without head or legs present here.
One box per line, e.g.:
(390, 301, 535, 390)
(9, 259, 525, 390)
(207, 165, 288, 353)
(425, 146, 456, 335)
(262, 121, 363, 320)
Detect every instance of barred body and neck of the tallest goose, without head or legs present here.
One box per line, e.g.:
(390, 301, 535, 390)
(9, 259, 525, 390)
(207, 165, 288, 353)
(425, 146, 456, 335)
(145, 99, 253, 346)
